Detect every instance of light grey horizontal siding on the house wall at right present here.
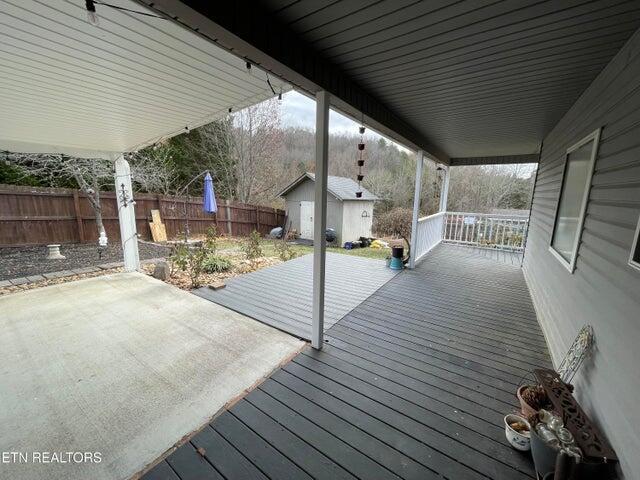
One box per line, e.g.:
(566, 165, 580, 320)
(524, 31, 640, 479)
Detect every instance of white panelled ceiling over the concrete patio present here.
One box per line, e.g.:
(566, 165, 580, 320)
(0, 0, 288, 157)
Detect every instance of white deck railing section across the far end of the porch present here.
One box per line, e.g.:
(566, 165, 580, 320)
(442, 212, 529, 250)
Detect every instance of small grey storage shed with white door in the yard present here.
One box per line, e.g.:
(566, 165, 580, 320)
(278, 172, 379, 245)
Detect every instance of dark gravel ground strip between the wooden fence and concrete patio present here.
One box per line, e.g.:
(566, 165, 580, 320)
(0, 242, 169, 280)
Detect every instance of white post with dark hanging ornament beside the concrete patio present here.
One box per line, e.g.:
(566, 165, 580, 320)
(115, 155, 140, 272)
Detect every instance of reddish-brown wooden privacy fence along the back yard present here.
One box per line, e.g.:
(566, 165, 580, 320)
(0, 185, 285, 246)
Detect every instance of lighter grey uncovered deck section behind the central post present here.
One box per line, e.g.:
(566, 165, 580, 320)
(195, 253, 398, 340)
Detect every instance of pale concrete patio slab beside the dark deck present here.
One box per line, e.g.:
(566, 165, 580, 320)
(0, 273, 303, 480)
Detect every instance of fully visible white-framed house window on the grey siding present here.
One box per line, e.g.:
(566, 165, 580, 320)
(550, 129, 600, 272)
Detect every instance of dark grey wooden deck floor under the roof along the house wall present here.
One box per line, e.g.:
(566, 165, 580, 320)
(144, 245, 549, 480)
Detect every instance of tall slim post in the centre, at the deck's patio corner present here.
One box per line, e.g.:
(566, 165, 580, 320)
(311, 91, 329, 350)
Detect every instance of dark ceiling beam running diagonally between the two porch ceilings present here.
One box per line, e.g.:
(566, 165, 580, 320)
(137, 0, 449, 164)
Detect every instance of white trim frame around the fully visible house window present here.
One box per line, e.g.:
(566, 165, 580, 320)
(549, 128, 601, 273)
